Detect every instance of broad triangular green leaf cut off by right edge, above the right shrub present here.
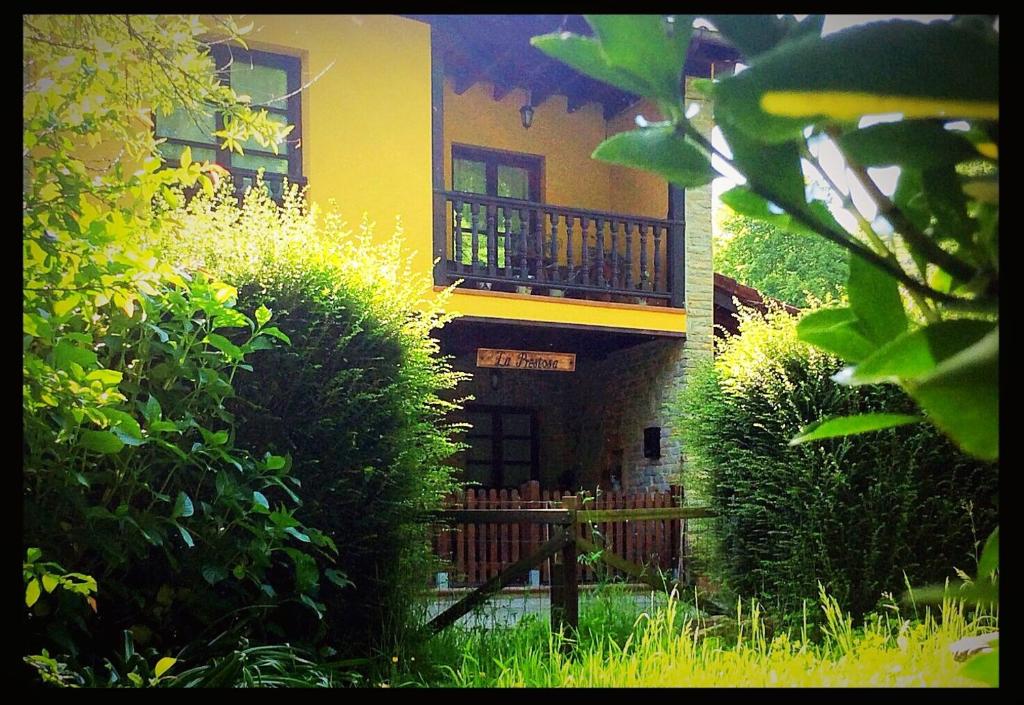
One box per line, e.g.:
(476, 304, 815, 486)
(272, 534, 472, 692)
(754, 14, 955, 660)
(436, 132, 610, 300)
(905, 328, 999, 460)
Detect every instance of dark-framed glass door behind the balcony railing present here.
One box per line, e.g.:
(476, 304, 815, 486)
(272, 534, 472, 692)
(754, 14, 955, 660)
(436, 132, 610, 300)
(452, 144, 544, 267)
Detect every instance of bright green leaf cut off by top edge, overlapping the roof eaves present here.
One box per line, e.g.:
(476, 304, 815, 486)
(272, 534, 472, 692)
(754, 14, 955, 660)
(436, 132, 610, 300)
(585, 14, 693, 103)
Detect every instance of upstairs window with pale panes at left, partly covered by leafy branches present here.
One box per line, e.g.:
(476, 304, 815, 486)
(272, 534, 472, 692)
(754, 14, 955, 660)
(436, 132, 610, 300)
(157, 45, 304, 199)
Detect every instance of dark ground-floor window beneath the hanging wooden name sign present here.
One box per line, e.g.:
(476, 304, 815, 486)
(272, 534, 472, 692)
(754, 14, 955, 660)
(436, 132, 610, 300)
(464, 405, 540, 488)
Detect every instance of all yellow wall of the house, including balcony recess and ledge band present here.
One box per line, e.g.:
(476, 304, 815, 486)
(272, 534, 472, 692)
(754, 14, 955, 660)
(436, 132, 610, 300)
(241, 15, 686, 333)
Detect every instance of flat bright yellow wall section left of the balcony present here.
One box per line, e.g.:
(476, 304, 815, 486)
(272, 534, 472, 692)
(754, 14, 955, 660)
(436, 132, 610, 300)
(247, 14, 433, 271)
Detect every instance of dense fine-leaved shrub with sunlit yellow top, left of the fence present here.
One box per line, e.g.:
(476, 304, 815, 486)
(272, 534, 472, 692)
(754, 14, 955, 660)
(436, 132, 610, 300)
(154, 179, 460, 652)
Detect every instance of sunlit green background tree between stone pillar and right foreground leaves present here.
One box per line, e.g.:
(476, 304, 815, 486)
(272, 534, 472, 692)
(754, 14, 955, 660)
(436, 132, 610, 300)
(715, 210, 850, 308)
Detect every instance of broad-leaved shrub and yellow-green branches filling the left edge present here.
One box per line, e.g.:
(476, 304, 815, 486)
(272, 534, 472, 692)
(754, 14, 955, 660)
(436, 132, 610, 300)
(23, 15, 323, 680)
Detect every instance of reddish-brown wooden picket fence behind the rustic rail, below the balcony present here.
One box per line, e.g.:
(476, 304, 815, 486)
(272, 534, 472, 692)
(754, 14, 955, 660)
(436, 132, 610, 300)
(434, 482, 686, 586)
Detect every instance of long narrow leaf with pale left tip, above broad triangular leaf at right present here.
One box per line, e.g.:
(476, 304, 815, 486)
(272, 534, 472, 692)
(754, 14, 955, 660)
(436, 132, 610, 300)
(836, 319, 995, 384)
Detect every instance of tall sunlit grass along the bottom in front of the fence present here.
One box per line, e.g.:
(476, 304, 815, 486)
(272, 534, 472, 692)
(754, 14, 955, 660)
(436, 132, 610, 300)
(391, 590, 998, 688)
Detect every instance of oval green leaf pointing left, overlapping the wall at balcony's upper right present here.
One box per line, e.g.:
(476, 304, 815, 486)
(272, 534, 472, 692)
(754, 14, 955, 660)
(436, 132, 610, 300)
(592, 126, 715, 186)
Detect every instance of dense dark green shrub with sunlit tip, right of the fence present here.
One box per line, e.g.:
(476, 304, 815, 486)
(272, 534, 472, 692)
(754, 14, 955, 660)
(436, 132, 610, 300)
(677, 312, 997, 614)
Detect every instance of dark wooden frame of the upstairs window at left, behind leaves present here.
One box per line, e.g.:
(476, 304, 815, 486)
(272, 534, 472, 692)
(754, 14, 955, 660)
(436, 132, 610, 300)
(154, 44, 306, 195)
